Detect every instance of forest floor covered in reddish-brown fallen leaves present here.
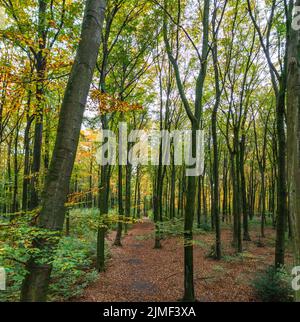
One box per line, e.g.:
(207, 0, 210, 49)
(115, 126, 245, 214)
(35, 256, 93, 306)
(74, 219, 292, 302)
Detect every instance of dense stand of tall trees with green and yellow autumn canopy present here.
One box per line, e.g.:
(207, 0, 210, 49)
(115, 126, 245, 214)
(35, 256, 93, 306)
(0, 0, 300, 301)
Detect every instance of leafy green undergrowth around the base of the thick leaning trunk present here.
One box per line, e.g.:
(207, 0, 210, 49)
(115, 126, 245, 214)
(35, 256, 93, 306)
(0, 209, 109, 302)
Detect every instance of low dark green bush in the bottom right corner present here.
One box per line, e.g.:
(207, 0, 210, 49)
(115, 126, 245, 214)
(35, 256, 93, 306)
(252, 266, 293, 302)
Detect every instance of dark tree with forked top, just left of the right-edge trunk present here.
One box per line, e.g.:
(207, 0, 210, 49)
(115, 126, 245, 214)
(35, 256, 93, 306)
(247, 0, 290, 267)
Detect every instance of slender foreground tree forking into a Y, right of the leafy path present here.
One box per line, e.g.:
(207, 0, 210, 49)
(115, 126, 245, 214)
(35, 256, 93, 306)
(163, 0, 210, 301)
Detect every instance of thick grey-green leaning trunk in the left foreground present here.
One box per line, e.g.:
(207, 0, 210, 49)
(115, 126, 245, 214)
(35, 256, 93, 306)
(21, 0, 106, 302)
